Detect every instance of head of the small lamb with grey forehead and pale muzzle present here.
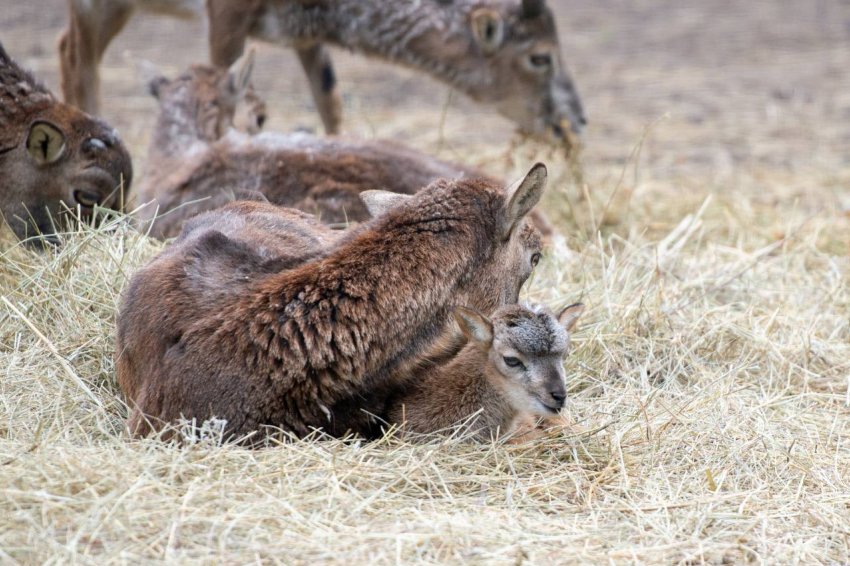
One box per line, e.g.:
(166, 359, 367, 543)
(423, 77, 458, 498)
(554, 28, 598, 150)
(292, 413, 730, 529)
(455, 303, 584, 416)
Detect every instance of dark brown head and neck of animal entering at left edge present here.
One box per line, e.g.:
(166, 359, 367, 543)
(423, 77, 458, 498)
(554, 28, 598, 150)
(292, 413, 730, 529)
(0, 44, 133, 247)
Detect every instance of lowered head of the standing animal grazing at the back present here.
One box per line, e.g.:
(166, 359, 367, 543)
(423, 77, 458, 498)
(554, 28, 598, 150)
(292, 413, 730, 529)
(458, 0, 587, 141)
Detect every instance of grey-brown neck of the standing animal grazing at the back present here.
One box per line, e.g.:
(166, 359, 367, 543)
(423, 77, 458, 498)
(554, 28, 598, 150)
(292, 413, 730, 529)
(307, 0, 490, 92)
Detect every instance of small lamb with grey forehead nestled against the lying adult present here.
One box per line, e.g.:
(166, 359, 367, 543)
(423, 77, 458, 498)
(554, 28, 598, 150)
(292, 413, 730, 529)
(388, 303, 584, 440)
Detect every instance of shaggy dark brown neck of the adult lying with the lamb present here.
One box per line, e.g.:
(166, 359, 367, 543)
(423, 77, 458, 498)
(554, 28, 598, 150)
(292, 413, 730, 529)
(245, 186, 495, 390)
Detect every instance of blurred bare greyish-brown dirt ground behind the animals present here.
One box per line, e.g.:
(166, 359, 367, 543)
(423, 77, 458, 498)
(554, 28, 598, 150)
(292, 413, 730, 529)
(6, 0, 850, 201)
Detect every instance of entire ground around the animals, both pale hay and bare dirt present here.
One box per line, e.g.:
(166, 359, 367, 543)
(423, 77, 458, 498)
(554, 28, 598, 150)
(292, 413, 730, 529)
(0, 0, 850, 566)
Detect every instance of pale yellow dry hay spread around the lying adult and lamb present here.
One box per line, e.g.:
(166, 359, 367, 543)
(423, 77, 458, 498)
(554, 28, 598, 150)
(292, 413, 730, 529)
(0, 153, 850, 566)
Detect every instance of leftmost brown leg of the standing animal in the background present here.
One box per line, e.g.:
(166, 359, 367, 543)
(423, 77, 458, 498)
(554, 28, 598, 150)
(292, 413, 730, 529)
(58, 0, 133, 115)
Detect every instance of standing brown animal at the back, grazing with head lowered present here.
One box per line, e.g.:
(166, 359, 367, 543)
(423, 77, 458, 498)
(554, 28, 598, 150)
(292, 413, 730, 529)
(59, 0, 586, 141)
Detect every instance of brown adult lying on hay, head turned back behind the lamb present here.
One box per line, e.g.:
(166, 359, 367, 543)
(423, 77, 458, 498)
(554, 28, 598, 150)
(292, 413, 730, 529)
(115, 164, 546, 437)
